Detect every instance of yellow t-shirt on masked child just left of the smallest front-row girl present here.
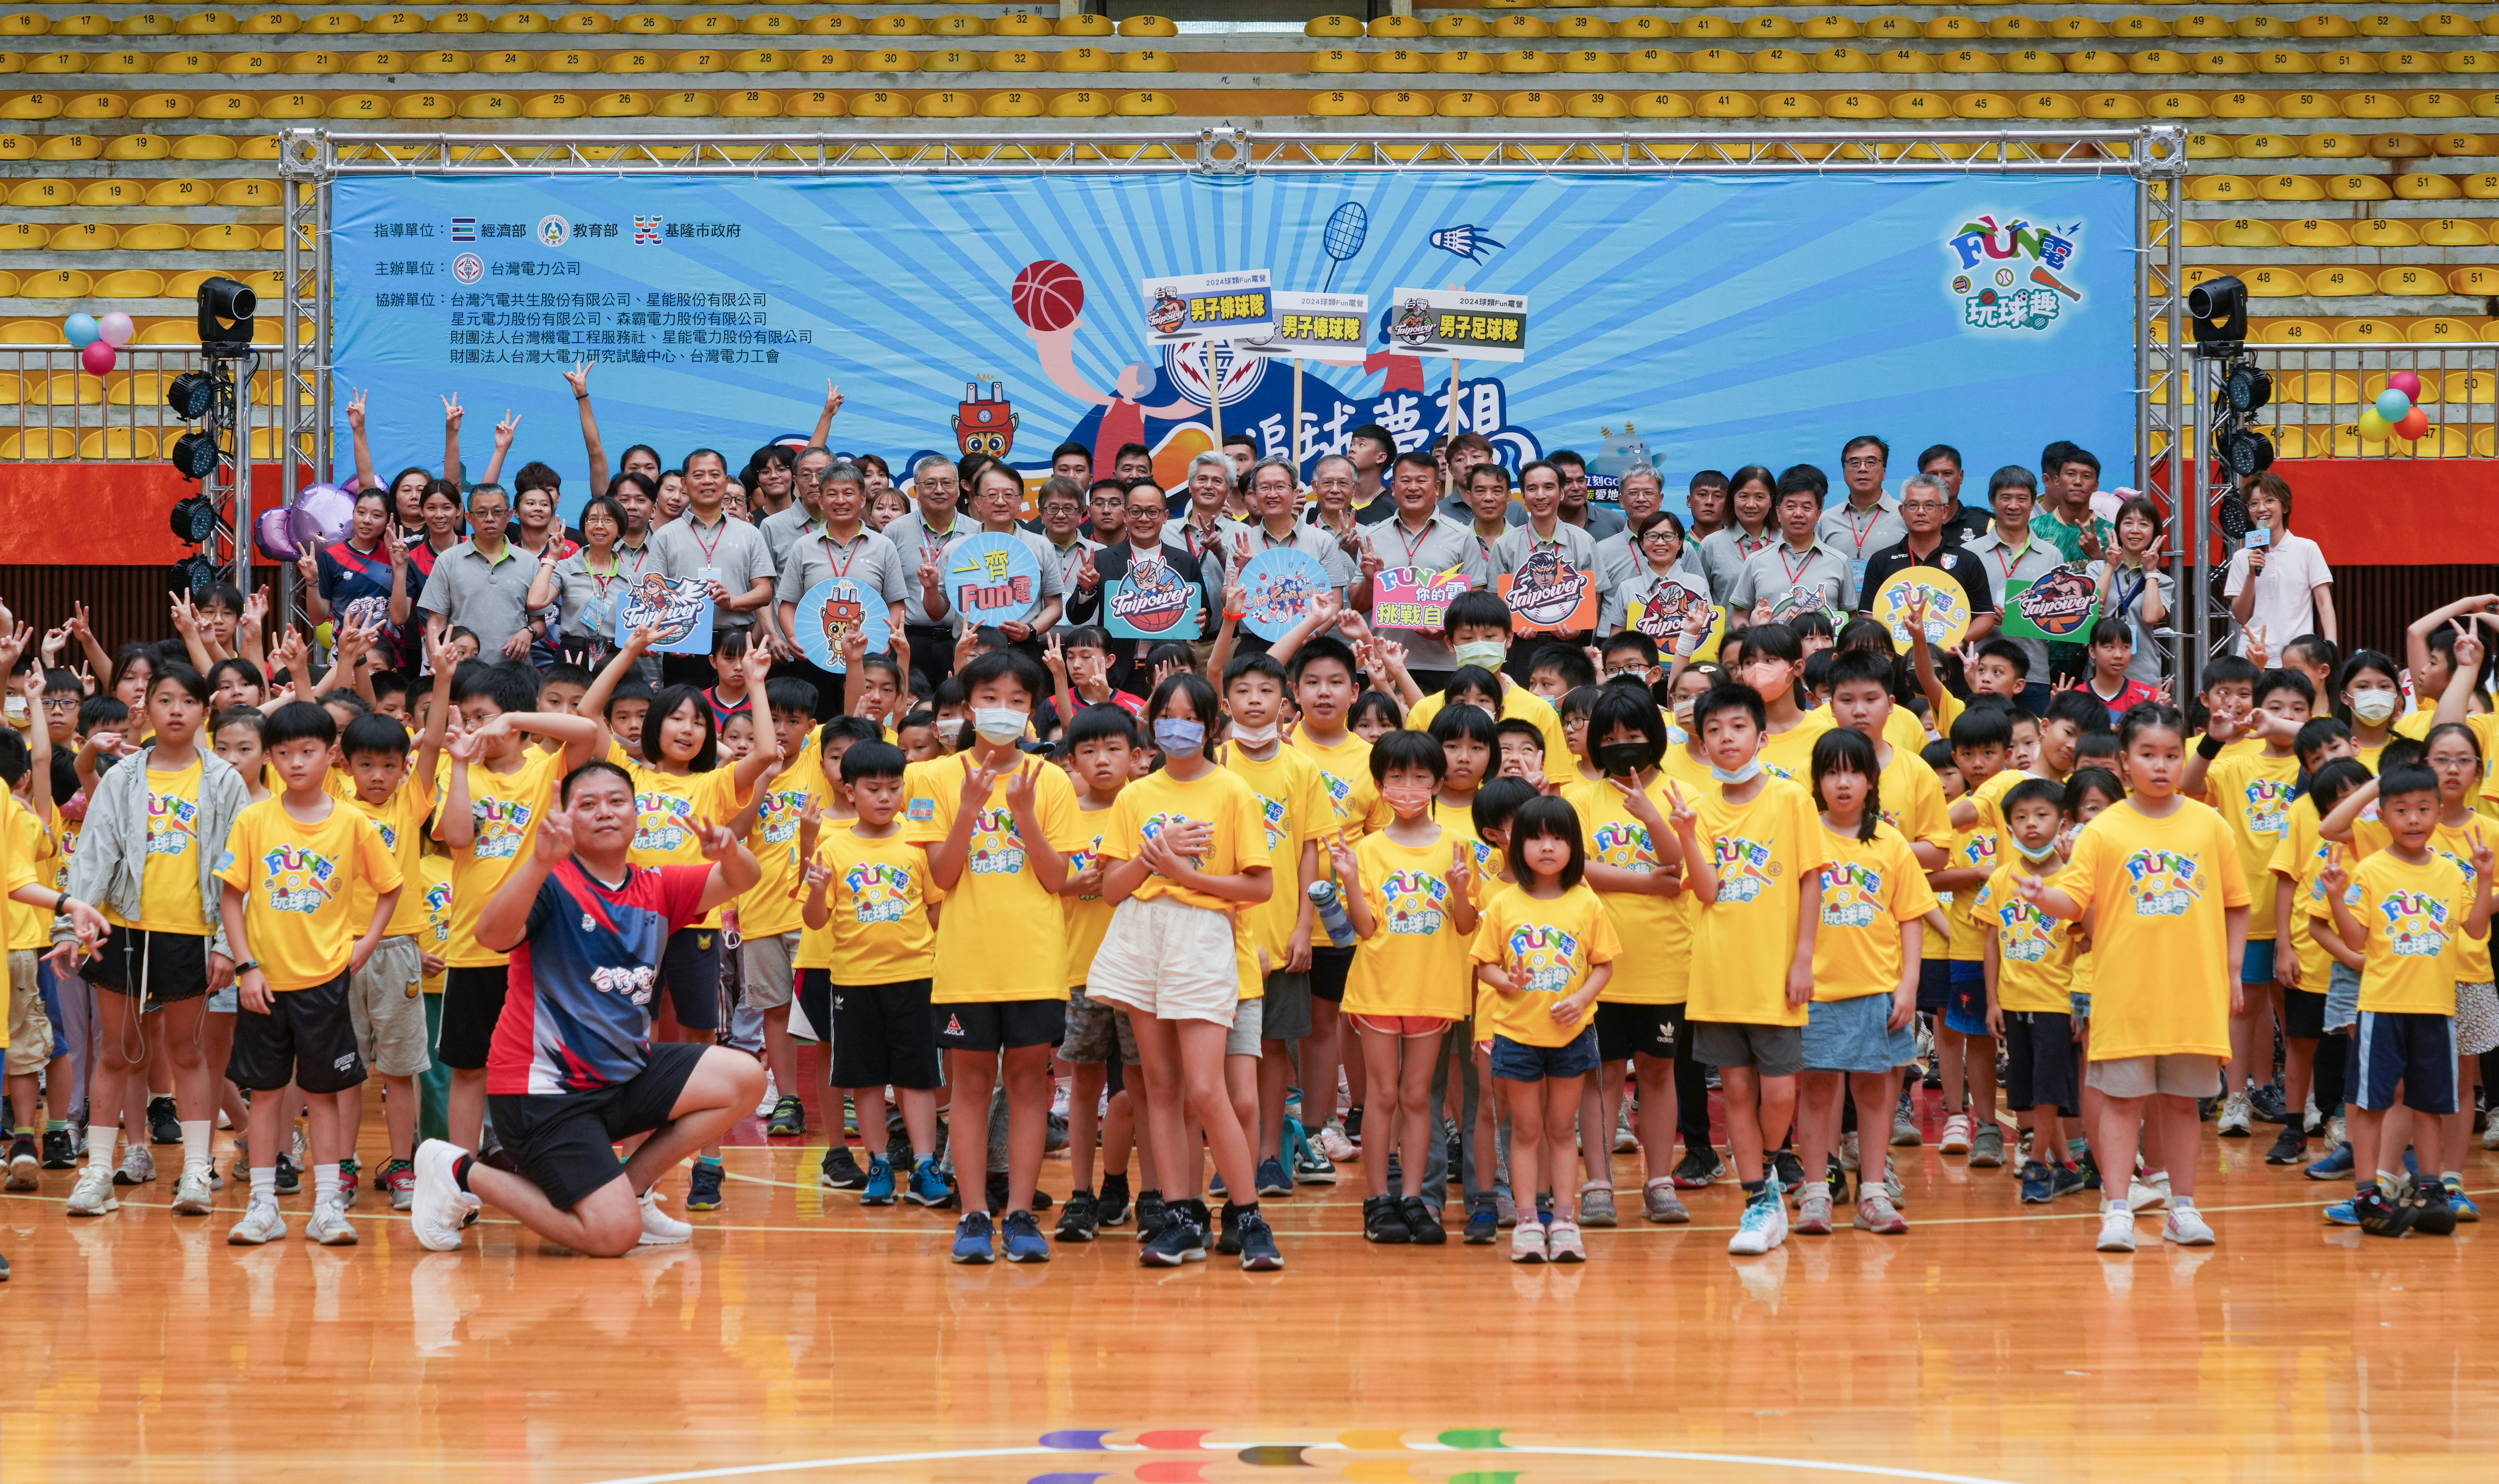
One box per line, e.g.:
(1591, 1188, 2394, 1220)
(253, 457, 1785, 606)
(1344, 827, 1497, 1019)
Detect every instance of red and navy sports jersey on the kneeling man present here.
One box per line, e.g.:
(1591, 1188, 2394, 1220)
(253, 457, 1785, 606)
(485, 859, 712, 1094)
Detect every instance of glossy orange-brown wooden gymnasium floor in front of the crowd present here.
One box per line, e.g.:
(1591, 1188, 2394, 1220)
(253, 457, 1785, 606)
(0, 1069, 2499, 1484)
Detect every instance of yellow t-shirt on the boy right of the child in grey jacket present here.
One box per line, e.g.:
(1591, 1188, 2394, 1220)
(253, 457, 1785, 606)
(217, 797, 400, 989)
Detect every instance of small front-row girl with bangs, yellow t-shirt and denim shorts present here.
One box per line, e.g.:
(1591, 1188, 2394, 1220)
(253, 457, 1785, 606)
(1472, 799, 1619, 1262)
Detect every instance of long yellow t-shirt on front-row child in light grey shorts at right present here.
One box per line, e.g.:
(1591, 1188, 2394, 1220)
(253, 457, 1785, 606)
(2049, 797, 2247, 1062)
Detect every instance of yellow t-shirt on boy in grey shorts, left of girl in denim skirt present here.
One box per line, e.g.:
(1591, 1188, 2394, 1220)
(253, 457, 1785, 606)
(1687, 780, 1832, 1025)
